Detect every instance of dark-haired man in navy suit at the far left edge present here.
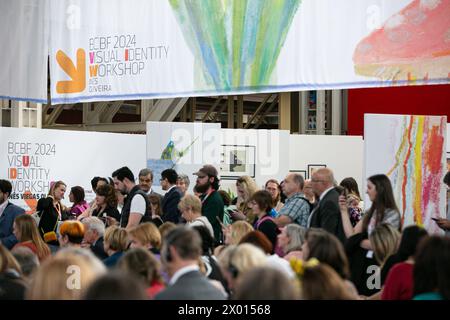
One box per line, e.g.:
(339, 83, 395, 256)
(0, 180, 25, 249)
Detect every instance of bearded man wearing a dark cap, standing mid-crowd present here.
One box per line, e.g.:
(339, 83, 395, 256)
(194, 165, 224, 245)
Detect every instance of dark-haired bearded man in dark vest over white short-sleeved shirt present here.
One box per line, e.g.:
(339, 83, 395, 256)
(109, 167, 152, 231)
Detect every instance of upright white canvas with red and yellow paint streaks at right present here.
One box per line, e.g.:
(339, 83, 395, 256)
(364, 115, 447, 233)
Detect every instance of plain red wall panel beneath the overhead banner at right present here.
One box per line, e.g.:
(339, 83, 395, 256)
(348, 85, 450, 135)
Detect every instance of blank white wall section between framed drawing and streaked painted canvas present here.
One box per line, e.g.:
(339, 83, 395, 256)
(289, 134, 365, 192)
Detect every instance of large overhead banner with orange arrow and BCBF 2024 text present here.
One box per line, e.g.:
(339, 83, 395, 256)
(50, 0, 450, 104)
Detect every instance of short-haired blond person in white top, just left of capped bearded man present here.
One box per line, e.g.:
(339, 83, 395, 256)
(178, 194, 214, 238)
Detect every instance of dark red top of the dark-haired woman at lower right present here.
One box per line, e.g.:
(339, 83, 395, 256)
(381, 259, 414, 300)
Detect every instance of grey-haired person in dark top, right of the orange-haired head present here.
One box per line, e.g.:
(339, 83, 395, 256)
(81, 217, 108, 260)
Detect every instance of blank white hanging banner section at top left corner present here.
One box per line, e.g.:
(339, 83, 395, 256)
(0, 0, 49, 103)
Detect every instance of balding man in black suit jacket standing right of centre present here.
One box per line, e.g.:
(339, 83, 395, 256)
(309, 168, 346, 243)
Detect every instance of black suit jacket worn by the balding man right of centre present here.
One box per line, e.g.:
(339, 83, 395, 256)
(310, 189, 346, 243)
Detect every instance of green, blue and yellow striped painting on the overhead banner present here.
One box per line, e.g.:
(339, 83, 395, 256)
(169, 0, 301, 90)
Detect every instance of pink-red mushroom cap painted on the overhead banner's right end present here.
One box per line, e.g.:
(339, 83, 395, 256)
(353, 0, 450, 84)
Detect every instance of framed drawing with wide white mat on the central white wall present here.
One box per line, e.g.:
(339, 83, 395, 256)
(220, 145, 256, 180)
